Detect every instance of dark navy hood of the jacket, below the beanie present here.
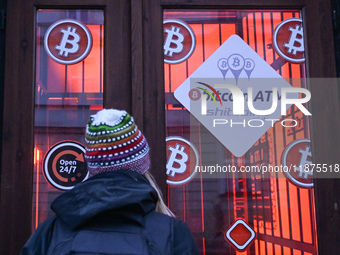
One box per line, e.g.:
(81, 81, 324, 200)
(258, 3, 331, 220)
(51, 170, 158, 229)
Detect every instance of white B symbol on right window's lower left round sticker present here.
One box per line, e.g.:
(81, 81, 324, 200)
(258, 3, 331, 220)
(166, 144, 189, 177)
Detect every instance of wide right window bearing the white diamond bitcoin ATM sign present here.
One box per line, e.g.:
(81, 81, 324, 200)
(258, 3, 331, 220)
(163, 10, 317, 255)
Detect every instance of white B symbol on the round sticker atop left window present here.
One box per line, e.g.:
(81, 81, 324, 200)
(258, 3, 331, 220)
(55, 26, 80, 58)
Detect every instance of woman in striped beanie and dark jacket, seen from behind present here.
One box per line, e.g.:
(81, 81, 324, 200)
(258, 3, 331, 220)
(21, 109, 199, 255)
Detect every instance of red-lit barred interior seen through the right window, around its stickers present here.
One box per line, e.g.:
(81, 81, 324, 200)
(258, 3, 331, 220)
(164, 10, 317, 255)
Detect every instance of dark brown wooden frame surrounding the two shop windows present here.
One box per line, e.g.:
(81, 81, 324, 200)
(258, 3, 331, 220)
(0, 0, 340, 255)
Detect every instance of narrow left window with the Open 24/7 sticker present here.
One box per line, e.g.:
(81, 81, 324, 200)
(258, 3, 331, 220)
(32, 9, 104, 230)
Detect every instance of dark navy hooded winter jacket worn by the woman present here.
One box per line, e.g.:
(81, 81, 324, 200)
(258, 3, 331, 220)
(21, 170, 199, 255)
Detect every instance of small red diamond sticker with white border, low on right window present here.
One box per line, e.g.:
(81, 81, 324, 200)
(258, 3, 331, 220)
(225, 219, 255, 251)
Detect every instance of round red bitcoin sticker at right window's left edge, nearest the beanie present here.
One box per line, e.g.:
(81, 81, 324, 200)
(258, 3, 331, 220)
(166, 136, 199, 185)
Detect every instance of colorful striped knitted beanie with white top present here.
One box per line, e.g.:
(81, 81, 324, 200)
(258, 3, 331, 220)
(85, 109, 150, 176)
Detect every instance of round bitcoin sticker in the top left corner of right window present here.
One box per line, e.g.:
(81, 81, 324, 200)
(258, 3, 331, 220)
(163, 19, 196, 64)
